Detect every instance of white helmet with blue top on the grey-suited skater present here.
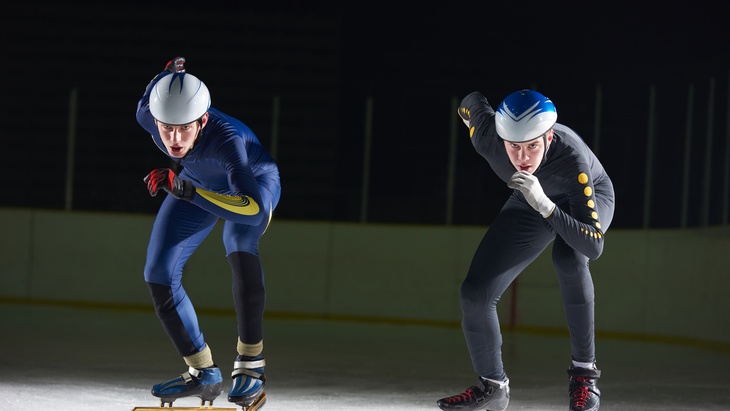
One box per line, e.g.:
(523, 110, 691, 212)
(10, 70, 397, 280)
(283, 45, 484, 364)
(495, 90, 558, 143)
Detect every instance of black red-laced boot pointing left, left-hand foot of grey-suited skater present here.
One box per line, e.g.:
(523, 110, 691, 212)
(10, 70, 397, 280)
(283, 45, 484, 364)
(436, 378, 509, 411)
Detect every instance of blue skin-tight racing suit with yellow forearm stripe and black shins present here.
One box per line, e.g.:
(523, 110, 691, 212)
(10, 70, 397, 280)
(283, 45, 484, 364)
(137, 71, 281, 356)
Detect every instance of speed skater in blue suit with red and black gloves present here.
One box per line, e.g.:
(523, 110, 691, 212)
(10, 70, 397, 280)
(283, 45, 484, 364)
(137, 57, 281, 409)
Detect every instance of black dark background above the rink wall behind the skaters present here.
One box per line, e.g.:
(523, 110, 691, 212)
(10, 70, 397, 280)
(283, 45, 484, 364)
(0, 1, 730, 227)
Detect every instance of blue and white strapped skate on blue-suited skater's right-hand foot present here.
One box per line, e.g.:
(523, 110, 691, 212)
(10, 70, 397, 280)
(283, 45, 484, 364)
(228, 355, 266, 411)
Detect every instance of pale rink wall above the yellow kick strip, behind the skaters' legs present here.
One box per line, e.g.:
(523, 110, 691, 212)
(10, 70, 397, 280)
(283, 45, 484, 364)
(0, 208, 730, 351)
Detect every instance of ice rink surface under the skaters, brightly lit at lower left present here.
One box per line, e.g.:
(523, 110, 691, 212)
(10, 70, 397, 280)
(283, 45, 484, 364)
(0, 303, 730, 411)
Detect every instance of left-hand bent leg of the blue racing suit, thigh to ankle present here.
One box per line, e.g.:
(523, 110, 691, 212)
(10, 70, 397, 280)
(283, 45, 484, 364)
(144, 195, 218, 356)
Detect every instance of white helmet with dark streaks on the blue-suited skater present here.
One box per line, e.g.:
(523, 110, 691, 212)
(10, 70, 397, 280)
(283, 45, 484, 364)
(150, 72, 210, 125)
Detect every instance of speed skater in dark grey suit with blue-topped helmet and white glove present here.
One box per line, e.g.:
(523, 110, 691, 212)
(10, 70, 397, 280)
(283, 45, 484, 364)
(437, 90, 614, 411)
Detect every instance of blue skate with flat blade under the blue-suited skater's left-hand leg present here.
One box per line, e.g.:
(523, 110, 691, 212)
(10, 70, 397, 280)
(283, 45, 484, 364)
(152, 366, 223, 407)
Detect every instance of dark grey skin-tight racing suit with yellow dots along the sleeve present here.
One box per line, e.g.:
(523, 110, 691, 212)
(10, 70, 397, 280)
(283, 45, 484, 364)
(459, 92, 614, 380)
